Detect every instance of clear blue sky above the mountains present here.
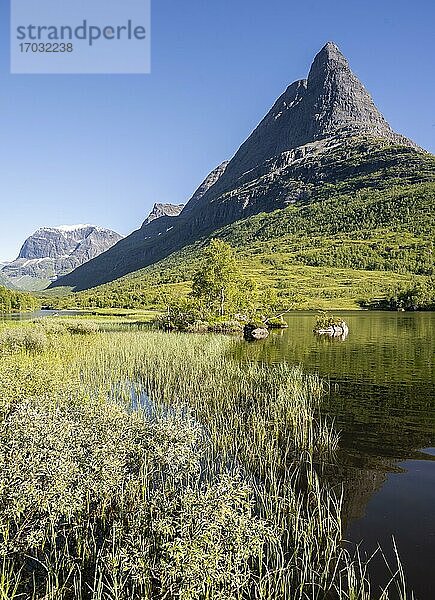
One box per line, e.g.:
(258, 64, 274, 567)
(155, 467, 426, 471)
(0, 0, 435, 260)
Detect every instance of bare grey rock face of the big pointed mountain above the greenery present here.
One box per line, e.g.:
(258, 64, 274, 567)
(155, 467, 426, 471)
(51, 42, 430, 290)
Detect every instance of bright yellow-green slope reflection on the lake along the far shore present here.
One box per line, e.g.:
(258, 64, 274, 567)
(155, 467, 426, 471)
(241, 312, 435, 389)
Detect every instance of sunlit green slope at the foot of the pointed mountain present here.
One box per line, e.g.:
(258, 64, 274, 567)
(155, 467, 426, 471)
(47, 145, 435, 308)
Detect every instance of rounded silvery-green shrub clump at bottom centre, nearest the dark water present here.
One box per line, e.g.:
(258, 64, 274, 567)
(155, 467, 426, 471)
(160, 476, 273, 600)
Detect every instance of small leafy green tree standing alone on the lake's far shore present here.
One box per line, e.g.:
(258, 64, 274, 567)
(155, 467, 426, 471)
(192, 239, 240, 317)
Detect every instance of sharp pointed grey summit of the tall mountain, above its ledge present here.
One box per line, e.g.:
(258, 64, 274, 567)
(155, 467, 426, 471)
(221, 42, 416, 185)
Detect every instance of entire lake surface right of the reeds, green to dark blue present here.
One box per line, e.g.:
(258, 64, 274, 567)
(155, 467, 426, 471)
(239, 311, 435, 600)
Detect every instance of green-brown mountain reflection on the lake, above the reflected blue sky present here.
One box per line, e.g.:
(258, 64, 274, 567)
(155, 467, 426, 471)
(237, 312, 435, 459)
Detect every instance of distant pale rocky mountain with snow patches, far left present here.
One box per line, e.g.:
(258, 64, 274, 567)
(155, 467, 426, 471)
(2, 225, 122, 289)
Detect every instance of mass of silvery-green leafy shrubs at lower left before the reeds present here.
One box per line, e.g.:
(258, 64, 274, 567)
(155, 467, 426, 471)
(0, 395, 272, 600)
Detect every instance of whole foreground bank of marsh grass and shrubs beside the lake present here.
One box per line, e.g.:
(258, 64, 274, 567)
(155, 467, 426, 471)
(0, 322, 412, 600)
